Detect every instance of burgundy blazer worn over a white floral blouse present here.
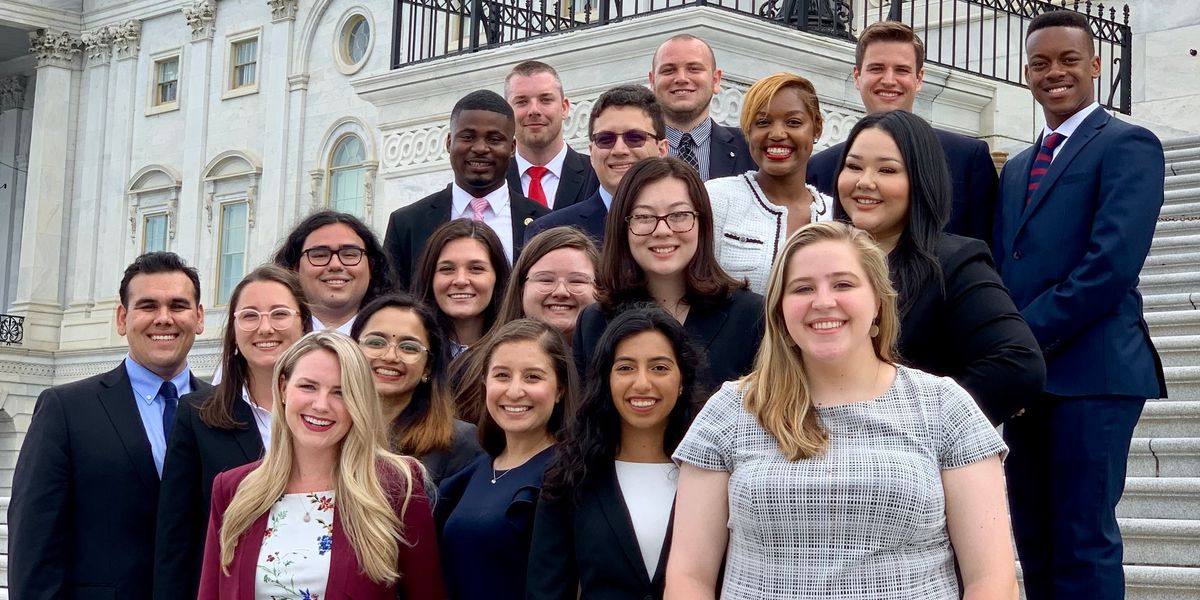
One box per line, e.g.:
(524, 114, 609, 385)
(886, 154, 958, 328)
(198, 461, 445, 600)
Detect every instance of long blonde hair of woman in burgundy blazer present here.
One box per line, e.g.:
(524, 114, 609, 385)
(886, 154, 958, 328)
(220, 331, 424, 583)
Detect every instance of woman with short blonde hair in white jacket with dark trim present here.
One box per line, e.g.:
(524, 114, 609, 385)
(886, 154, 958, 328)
(704, 73, 833, 294)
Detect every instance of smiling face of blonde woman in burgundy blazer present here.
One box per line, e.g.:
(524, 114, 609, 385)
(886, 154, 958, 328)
(283, 348, 350, 452)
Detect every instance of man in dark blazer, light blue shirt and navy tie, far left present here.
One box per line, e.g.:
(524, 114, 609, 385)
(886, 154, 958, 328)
(8, 252, 209, 600)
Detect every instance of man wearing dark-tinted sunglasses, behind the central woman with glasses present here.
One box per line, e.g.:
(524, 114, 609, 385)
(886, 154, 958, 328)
(526, 85, 667, 247)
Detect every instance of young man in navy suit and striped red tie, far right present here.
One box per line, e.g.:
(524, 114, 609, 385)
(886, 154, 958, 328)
(992, 10, 1166, 600)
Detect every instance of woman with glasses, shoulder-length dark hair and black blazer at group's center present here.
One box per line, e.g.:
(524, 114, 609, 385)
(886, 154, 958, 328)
(572, 157, 763, 384)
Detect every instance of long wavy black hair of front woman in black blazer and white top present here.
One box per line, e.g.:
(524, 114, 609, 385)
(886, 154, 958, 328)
(541, 302, 703, 500)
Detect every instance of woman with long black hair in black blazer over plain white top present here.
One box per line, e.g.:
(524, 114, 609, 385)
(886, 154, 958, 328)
(526, 304, 702, 600)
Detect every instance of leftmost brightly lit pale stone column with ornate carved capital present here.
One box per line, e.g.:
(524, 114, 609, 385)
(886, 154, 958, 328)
(11, 30, 83, 350)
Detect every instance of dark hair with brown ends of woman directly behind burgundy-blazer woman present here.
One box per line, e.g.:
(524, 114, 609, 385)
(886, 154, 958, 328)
(350, 294, 455, 456)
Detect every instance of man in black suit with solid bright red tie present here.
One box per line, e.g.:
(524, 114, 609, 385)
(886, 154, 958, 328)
(504, 60, 600, 209)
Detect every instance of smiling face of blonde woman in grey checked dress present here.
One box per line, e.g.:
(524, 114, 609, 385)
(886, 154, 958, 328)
(780, 241, 880, 364)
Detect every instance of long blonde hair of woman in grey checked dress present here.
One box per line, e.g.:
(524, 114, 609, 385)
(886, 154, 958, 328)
(739, 222, 900, 461)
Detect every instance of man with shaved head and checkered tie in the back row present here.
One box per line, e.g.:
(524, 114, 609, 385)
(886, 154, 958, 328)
(649, 34, 758, 181)
